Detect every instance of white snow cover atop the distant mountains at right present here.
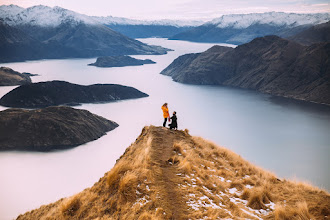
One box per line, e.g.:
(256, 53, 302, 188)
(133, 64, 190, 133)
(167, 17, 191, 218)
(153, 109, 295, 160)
(210, 12, 330, 29)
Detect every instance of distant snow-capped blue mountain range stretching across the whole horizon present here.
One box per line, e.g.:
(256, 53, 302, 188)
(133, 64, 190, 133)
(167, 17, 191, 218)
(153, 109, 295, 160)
(0, 5, 330, 46)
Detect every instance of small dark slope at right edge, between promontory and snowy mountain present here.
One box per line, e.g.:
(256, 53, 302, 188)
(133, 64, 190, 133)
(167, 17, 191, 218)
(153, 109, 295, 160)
(288, 21, 330, 45)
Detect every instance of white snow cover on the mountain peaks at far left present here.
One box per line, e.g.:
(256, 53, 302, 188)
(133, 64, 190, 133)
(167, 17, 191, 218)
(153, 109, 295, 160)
(0, 5, 98, 27)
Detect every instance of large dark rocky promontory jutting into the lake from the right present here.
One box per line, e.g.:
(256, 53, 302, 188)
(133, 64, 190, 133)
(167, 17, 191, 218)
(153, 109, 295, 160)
(161, 36, 330, 104)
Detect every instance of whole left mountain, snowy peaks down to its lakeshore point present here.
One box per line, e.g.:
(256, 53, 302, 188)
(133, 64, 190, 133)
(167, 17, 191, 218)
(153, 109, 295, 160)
(0, 5, 167, 62)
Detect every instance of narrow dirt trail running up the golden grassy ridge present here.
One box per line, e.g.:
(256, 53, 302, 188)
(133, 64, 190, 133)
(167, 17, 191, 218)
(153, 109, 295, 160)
(151, 128, 188, 219)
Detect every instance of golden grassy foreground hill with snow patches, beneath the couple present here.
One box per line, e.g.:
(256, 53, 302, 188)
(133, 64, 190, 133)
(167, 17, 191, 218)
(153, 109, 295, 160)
(18, 126, 330, 219)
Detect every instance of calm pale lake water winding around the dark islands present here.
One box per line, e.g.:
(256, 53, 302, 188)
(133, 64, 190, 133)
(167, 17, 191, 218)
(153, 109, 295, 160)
(0, 38, 330, 219)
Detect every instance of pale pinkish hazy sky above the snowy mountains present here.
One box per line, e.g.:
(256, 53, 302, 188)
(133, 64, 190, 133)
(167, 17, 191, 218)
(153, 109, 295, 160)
(0, 0, 330, 20)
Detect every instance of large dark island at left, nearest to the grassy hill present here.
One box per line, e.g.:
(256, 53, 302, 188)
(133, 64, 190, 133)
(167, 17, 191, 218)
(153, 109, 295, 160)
(0, 106, 118, 151)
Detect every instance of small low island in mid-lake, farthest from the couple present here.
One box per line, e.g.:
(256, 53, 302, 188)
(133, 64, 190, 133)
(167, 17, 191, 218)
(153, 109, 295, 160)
(88, 56, 156, 67)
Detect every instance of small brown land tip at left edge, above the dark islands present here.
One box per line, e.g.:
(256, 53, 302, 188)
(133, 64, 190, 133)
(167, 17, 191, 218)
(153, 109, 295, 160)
(0, 67, 31, 86)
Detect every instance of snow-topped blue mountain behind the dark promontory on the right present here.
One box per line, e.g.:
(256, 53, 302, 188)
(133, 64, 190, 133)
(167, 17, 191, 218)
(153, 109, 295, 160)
(170, 12, 330, 44)
